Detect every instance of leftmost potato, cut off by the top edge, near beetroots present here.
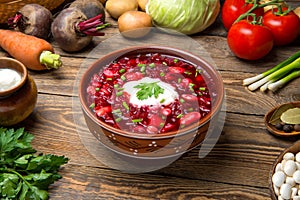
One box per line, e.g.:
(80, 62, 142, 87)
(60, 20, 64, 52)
(105, 0, 138, 19)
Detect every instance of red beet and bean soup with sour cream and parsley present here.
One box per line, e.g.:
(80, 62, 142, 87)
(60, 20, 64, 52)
(87, 53, 211, 134)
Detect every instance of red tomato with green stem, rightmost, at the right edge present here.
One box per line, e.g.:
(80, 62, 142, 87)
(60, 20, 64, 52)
(262, 8, 300, 46)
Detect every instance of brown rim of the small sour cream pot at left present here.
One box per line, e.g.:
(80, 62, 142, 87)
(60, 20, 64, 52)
(0, 57, 28, 97)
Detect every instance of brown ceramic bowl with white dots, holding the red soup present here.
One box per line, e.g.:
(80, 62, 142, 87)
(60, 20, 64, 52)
(79, 46, 224, 158)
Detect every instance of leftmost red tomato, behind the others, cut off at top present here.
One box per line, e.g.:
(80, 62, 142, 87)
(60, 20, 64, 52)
(221, 0, 264, 30)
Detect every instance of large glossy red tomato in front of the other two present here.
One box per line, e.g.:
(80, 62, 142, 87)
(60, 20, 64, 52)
(227, 20, 274, 60)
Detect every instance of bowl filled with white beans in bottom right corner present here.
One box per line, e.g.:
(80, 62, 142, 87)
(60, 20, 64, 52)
(270, 141, 300, 200)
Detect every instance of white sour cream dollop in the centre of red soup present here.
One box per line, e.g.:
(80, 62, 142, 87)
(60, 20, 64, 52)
(123, 77, 179, 107)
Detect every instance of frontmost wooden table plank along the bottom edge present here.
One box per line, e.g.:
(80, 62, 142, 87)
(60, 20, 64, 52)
(49, 165, 269, 200)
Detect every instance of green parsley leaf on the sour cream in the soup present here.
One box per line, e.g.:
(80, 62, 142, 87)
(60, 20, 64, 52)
(134, 82, 164, 100)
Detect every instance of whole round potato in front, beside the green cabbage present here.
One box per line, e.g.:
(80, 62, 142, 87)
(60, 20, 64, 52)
(118, 11, 152, 38)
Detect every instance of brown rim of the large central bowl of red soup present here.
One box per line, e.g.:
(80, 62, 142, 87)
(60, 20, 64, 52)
(79, 45, 224, 139)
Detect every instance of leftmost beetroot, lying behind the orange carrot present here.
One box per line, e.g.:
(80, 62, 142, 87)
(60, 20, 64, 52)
(8, 4, 53, 39)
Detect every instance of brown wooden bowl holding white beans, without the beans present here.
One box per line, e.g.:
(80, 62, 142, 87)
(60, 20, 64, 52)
(269, 141, 300, 200)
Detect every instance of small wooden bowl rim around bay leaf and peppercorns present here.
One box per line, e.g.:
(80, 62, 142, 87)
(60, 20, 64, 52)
(264, 101, 300, 137)
